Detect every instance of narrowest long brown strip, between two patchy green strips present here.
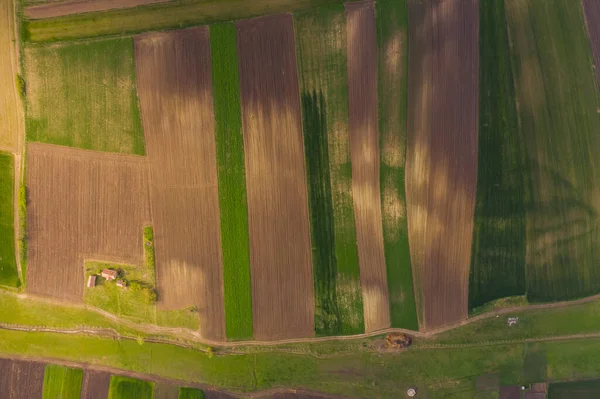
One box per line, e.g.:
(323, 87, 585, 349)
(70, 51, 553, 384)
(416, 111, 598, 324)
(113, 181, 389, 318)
(345, 2, 390, 332)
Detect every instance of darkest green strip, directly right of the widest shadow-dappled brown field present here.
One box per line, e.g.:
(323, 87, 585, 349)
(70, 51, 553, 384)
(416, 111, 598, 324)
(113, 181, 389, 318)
(469, 0, 526, 309)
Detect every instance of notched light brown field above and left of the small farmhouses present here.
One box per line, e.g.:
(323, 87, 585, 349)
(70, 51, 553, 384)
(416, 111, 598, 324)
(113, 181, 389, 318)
(27, 143, 150, 302)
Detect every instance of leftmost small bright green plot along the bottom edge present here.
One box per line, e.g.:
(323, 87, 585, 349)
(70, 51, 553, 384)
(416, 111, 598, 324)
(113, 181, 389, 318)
(42, 364, 83, 399)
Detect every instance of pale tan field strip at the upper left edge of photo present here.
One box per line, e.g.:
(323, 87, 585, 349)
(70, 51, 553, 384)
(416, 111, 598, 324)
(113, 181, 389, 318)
(0, 0, 23, 150)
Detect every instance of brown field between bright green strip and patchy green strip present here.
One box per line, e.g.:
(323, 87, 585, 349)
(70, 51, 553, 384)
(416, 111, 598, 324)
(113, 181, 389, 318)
(237, 14, 314, 340)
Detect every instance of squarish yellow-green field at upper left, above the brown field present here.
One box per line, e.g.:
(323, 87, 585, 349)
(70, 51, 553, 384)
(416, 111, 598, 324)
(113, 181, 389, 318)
(25, 39, 144, 155)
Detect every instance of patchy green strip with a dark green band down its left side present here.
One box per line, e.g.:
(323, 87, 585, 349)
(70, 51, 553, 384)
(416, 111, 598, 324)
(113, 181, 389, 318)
(294, 4, 365, 336)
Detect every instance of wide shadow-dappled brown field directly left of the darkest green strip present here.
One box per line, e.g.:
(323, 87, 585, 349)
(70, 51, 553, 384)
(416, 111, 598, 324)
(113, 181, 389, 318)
(406, 0, 479, 329)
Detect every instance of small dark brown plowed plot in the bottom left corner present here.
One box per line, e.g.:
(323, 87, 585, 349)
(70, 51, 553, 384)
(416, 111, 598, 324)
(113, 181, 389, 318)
(0, 359, 46, 399)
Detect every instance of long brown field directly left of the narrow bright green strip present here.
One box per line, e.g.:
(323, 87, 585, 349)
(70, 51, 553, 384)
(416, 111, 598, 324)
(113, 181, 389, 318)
(134, 27, 226, 340)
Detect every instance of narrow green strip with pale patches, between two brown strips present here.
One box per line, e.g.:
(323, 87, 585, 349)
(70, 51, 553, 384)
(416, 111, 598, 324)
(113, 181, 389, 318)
(375, 0, 419, 330)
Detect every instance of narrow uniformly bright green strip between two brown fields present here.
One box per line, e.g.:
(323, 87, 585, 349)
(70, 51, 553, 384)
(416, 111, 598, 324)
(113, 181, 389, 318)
(210, 24, 252, 340)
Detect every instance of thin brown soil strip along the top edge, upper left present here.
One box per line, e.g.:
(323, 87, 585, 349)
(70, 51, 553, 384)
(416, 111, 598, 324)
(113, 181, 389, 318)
(25, 0, 170, 19)
